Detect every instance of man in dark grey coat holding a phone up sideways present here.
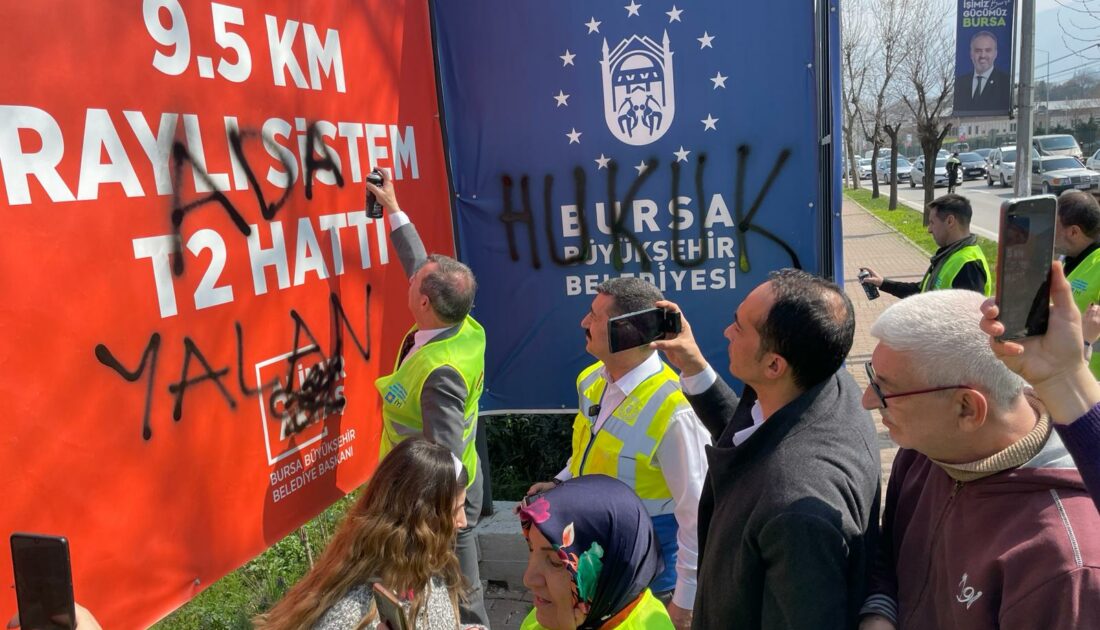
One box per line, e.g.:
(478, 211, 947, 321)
(653, 269, 881, 630)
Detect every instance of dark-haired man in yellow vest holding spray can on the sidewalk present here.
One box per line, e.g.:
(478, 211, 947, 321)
(861, 194, 993, 298)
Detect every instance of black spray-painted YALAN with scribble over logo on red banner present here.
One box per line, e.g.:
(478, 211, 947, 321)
(96, 285, 371, 440)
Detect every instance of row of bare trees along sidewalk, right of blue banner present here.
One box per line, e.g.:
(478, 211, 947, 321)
(840, 0, 956, 210)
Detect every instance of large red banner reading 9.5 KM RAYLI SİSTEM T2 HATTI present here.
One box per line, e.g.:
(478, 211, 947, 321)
(0, 0, 453, 628)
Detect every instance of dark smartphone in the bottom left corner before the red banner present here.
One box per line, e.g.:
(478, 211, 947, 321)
(11, 532, 76, 630)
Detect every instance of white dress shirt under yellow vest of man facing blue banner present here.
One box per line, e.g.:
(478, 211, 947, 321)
(557, 352, 711, 610)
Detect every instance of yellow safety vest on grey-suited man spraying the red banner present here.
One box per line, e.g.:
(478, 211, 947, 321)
(374, 316, 485, 487)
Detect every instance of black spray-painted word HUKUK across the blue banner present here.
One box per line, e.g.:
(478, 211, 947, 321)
(498, 144, 802, 273)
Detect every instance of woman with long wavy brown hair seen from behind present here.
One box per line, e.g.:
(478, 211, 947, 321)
(255, 438, 466, 630)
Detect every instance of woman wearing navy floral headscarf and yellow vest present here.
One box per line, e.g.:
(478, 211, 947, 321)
(518, 475, 672, 630)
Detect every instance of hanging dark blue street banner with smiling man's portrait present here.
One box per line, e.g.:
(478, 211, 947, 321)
(954, 0, 1014, 118)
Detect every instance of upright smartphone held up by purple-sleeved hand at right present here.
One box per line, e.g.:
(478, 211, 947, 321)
(997, 195, 1058, 341)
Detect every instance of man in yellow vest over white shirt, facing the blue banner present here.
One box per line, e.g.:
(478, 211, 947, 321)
(527, 278, 710, 630)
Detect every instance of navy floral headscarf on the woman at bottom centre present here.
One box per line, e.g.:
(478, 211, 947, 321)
(518, 475, 664, 630)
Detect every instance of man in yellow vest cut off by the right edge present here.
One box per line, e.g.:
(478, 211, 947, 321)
(1054, 190, 1100, 378)
